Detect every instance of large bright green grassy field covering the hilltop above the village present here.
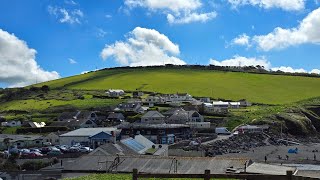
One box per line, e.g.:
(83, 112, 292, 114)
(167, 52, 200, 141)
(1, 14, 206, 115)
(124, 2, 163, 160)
(38, 68, 320, 104)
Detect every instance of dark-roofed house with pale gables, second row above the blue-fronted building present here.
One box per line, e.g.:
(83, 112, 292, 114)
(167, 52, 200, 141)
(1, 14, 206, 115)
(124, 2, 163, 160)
(58, 111, 98, 122)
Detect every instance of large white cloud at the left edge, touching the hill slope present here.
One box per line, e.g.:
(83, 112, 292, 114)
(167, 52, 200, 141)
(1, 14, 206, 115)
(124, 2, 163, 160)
(0, 29, 60, 87)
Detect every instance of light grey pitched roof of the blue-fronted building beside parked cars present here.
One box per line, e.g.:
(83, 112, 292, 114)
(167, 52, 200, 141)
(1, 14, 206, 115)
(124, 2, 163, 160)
(60, 127, 118, 137)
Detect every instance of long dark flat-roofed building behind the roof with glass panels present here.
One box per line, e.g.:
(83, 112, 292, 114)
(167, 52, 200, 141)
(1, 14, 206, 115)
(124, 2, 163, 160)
(118, 123, 191, 144)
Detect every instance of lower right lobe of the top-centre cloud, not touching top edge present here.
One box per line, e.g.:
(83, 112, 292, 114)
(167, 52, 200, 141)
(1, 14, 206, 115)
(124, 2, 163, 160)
(167, 12, 217, 24)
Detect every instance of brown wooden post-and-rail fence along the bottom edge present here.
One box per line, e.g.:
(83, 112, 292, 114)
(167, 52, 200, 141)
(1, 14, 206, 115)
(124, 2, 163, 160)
(132, 169, 318, 180)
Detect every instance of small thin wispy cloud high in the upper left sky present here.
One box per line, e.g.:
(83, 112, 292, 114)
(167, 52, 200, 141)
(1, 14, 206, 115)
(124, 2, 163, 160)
(48, 6, 84, 24)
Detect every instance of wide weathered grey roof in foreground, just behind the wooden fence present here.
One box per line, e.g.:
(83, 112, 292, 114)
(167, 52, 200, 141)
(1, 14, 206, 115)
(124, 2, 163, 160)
(64, 155, 249, 174)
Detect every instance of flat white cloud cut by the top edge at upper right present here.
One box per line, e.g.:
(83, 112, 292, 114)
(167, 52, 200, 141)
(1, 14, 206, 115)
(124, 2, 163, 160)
(228, 0, 306, 11)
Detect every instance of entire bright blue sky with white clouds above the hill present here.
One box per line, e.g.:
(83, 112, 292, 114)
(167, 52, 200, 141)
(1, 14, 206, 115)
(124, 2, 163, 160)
(0, 0, 320, 86)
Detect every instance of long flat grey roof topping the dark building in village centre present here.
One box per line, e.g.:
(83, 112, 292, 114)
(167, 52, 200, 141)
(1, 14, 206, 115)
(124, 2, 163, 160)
(118, 123, 189, 129)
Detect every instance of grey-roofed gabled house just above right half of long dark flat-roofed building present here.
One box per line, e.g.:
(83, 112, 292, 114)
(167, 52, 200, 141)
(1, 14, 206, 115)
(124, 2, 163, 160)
(166, 110, 204, 124)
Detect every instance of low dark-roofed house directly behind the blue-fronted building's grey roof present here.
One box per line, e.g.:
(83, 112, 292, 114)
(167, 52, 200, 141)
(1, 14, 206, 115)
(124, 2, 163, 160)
(50, 119, 98, 129)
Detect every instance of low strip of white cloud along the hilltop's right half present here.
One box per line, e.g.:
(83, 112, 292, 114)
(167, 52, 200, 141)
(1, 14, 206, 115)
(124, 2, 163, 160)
(209, 55, 320, 74)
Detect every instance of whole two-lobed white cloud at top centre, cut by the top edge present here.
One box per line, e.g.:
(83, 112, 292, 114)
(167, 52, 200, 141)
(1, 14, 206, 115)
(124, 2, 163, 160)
(124, 0, 217, 24)
